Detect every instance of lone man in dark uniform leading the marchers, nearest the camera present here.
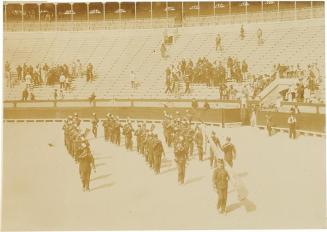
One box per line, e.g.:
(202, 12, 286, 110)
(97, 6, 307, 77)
(212, 159, 229, 213)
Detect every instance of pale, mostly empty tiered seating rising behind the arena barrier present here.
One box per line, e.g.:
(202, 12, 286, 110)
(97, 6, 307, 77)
(4, 19, 324, 100)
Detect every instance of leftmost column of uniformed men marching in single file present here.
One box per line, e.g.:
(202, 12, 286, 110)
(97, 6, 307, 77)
(63, 113, 96, 191)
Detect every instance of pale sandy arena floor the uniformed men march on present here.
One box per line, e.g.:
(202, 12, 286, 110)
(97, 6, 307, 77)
(2, 122, 326, 230)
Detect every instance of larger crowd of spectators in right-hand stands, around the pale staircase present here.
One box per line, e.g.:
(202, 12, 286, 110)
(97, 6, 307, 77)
(165, 57, 322, 102)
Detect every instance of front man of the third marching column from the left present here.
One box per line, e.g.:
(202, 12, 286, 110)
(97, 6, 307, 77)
(174, 136, 186, 184)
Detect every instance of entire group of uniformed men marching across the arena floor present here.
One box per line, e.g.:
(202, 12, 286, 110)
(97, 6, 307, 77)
(63, 110, 241, 213)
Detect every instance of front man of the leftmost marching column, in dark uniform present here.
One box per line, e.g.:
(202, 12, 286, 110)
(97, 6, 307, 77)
(79, 143, 95, 191)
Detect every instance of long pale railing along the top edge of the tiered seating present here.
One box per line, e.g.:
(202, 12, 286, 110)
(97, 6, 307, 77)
(4, 7, 324, 31)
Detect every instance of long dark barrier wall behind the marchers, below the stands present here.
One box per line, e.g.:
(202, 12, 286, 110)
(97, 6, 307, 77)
(3, 106, 241, 123)
